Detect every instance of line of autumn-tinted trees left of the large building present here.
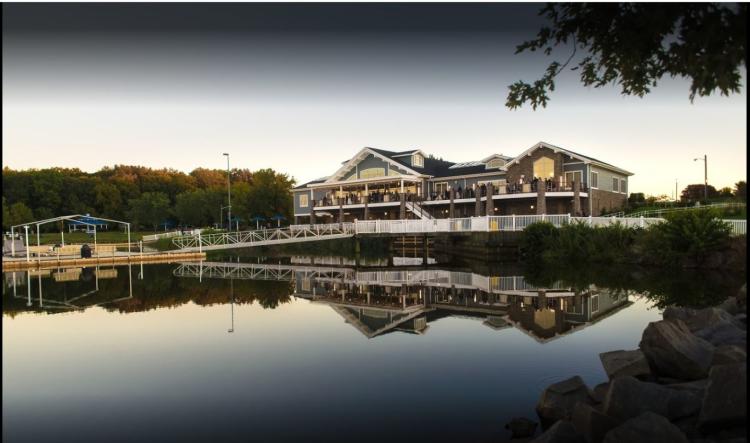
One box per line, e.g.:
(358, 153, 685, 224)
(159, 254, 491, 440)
(3, 165, 295, 230)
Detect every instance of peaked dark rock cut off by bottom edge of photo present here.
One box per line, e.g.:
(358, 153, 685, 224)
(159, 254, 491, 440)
(604, 412, 688, 443)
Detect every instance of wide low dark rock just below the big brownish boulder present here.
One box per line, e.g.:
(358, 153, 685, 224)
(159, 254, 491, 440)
(602, 377, 701, 420)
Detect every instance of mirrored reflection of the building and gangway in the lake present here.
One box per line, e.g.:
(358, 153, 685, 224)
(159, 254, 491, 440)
(173, 260, 630, 342)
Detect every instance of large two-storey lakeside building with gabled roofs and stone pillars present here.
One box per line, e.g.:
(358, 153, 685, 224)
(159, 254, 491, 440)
(293, 142, 633, 223)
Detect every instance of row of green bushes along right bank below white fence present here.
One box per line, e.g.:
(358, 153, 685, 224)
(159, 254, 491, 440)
(520, 210, 747, 270)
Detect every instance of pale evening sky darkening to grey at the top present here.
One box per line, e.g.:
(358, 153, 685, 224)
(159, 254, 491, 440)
(2, 3, 747, 196)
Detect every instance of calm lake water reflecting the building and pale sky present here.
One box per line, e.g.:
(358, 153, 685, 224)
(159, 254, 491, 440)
(3, 257, 748, 442)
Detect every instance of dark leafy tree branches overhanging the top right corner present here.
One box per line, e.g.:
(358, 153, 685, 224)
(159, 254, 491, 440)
(506, 3, 747, 109)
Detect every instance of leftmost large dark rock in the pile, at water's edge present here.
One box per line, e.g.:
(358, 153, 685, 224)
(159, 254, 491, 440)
(536, 375, 591, 429)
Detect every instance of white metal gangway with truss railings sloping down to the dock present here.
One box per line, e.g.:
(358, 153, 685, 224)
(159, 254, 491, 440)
(172, 223, 355, 252)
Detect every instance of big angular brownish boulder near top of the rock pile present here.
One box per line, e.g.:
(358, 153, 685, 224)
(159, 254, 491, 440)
(639, 319, 714, 380)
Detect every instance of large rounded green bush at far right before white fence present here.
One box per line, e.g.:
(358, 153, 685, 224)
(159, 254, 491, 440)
(640, 210, 732, 265)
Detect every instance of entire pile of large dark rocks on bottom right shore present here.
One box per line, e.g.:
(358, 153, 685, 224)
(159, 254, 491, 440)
(506, 286, 747, 443)
